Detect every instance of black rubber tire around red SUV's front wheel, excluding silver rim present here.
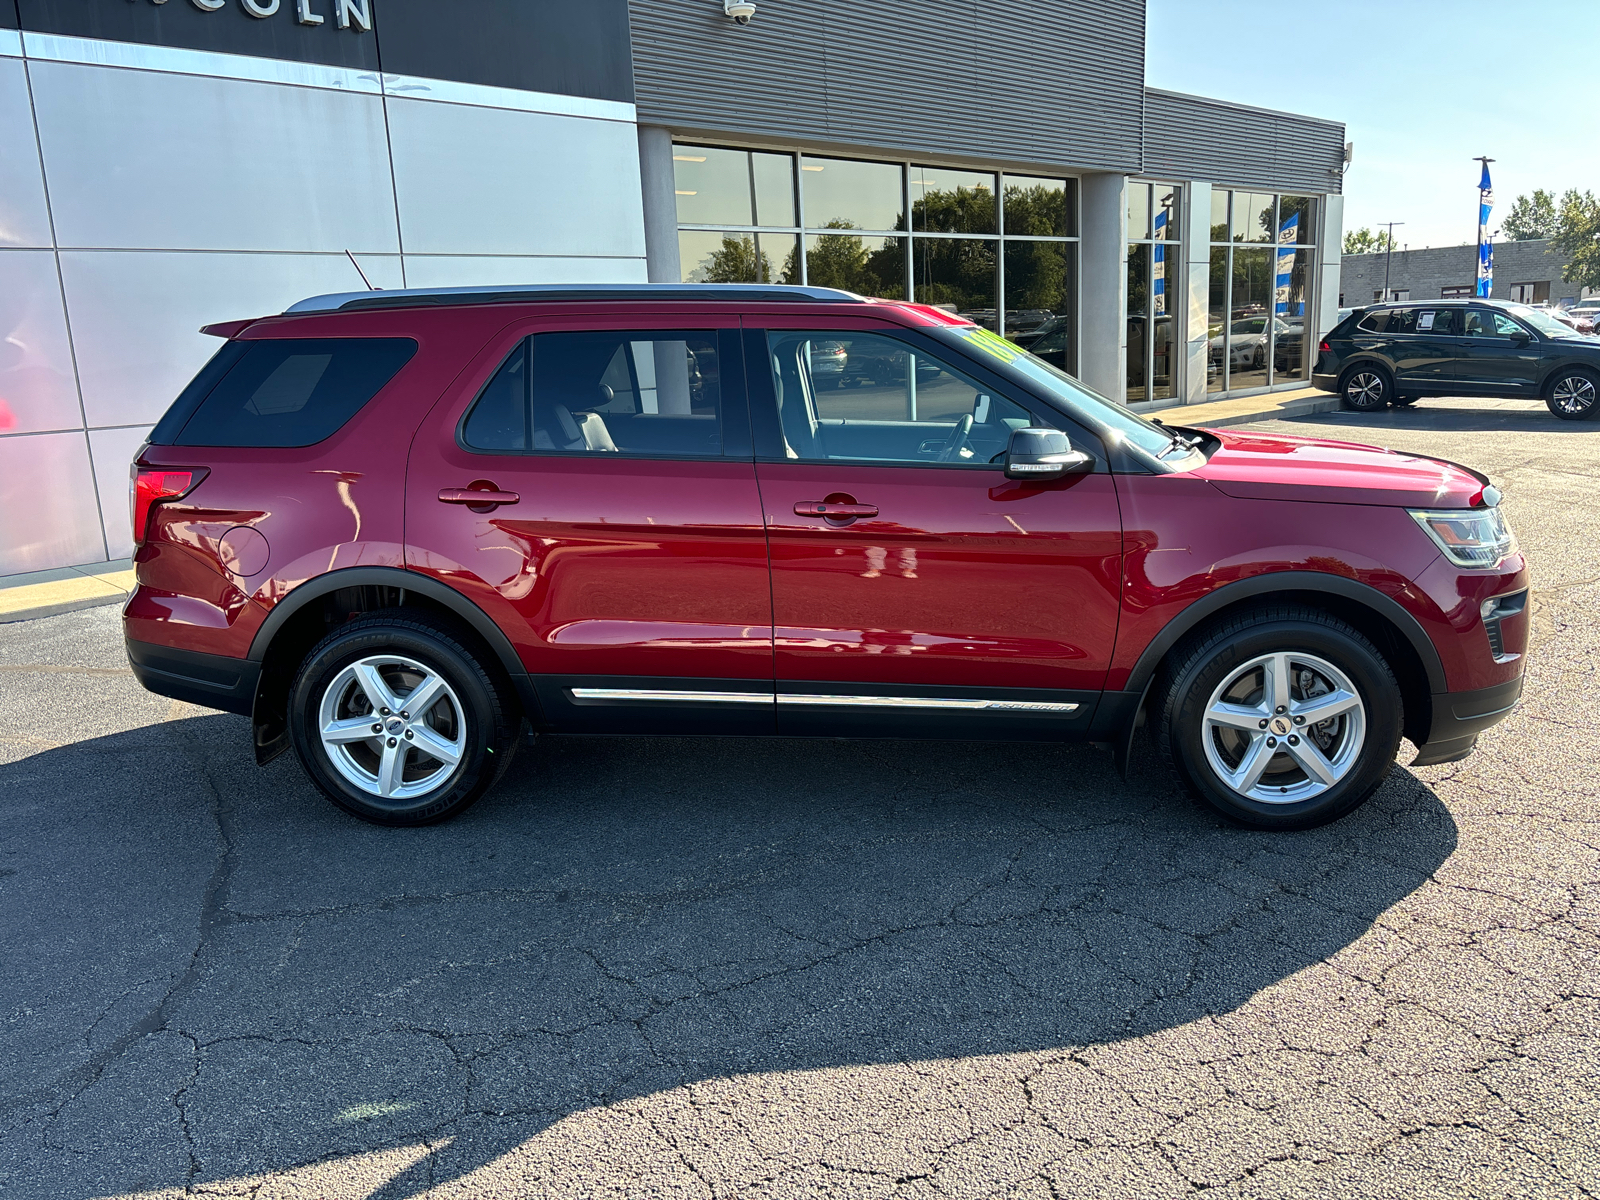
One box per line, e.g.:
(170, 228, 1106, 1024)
(1163, 618, 1405, 829)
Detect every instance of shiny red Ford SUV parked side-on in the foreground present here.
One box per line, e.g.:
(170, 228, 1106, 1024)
(125, 285, 1528, 829)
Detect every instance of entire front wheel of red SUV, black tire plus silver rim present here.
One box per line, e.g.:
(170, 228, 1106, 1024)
(1157, 606, 1405, 830)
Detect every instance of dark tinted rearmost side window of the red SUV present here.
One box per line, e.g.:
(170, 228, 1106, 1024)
(176, 338, 416, 446)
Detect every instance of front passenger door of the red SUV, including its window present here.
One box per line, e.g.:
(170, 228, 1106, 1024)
(746, 315, 1122, 738)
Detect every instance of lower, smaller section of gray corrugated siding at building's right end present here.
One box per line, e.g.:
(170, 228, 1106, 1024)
(1144, 88, 1344, 194)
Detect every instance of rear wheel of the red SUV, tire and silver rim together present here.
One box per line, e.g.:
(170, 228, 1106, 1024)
(290, 610, 520, 826)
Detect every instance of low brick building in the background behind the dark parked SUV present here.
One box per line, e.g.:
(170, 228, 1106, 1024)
(1339, 238, 1597, 307)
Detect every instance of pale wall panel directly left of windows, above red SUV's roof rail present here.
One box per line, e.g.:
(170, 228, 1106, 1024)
(389, 99, 645, 258)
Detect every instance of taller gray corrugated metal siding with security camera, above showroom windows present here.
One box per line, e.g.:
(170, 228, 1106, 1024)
(629, 0, 1144, 171)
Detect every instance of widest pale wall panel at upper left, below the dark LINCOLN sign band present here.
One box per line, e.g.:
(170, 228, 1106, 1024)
(30, 61, 398, 253)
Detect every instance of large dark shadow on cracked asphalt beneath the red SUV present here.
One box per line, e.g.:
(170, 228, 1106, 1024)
(0, 715, 1456, 1197)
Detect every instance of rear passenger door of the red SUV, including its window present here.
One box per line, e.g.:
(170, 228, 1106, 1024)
(406, 315, 773, 733)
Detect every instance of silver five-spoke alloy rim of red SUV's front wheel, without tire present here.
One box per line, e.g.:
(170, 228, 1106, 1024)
(1202, 651, 1366, 805)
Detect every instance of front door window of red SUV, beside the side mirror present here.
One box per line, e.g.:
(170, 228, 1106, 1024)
(768, 330, 1037, 467)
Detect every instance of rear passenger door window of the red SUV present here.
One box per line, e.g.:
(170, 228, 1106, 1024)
(461, 331, 722, 458)
